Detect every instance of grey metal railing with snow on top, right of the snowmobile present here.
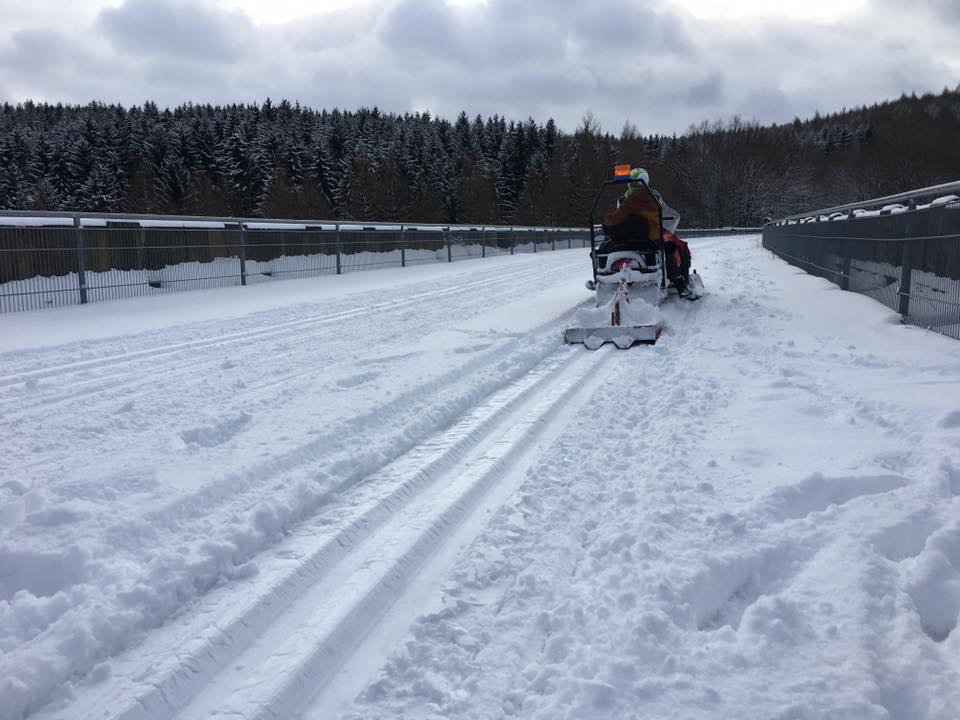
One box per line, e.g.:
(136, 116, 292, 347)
(763, 182, 960, 339)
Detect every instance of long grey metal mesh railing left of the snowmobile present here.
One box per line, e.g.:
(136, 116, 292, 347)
(0, 212, 590, 313)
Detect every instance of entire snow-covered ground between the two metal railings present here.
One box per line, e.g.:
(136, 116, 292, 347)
(0, 236, 960, 720)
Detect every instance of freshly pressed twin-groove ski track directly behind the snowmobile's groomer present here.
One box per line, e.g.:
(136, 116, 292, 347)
(58, 347, 613, 720)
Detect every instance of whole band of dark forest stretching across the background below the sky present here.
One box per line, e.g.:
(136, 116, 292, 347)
(0, 87, 960, 227)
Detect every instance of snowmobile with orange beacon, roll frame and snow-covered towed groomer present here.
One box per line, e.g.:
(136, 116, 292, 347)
(564, 166, 703, 350)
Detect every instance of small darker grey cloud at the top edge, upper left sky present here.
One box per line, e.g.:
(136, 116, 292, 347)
(97, 0, 255, 61)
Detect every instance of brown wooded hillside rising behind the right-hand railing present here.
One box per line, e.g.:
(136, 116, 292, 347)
(644, 87, 960, 225)
